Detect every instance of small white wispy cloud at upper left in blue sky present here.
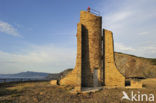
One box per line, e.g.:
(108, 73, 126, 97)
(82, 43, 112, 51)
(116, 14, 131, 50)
(0, 21, 21, 37)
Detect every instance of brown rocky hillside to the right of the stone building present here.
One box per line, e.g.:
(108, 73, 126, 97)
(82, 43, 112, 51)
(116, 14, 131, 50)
(115, 52, 156, 78)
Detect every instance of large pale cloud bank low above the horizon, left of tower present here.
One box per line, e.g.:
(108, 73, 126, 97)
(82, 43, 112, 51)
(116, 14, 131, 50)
(0, 45, 76, 73)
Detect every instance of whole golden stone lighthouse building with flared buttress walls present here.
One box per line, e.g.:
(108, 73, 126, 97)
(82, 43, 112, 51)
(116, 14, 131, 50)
(60, 11, 125, 91)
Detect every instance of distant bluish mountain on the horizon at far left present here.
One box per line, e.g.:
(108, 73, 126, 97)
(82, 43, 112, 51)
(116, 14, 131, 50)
(0, 71, 49, 78)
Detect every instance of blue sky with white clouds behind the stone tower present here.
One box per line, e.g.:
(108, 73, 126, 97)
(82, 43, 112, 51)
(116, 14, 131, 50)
(0, 0, 156, 74)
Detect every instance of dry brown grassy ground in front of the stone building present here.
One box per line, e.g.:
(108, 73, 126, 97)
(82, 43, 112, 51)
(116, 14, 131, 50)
(0, 79, 156, 103)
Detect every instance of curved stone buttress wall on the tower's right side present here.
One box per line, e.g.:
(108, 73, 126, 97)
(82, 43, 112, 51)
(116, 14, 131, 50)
(103, 29, 125, 87)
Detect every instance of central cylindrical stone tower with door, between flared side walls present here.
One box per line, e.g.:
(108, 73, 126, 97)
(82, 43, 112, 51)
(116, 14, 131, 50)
(80, 11, 102, 87)
